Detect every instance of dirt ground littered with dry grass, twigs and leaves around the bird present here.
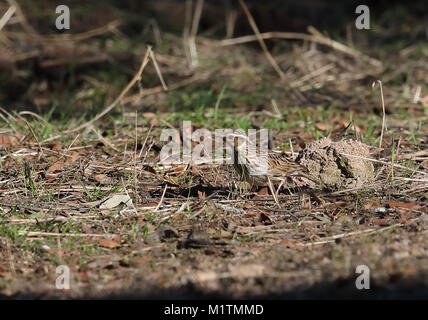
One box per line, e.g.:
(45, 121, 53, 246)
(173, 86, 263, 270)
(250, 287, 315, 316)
(0, 1, 428, 299)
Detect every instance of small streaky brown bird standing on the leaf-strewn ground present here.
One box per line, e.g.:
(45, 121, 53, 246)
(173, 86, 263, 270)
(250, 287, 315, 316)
(226, 133, 315, 207)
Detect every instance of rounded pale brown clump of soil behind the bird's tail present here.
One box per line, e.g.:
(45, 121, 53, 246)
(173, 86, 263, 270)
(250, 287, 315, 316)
(296, 138, 374, 190)
